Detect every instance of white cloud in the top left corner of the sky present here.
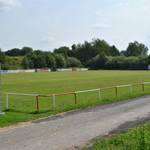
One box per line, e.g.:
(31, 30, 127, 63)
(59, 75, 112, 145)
(0, 0, 20, 11)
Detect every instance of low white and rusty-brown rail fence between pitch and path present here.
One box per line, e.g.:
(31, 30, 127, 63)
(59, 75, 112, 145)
(6, 82, 150, 112)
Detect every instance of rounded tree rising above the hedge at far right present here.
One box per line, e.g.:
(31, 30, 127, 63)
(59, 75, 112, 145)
(126, 41, 148, 56)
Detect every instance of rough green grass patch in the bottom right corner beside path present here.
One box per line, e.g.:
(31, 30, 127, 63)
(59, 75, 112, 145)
(83, 123, 150, 150)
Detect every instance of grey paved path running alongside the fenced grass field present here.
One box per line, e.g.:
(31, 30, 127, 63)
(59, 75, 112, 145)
(0, 96, 150, 150)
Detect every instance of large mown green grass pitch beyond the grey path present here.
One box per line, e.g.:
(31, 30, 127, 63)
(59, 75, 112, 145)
(0, 71, 150, 127)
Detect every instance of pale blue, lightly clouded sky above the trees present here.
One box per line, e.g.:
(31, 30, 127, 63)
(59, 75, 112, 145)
(0, 0, 150, 51)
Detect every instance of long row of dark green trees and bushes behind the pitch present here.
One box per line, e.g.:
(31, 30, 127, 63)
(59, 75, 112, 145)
(0, 39, 150, 71)
